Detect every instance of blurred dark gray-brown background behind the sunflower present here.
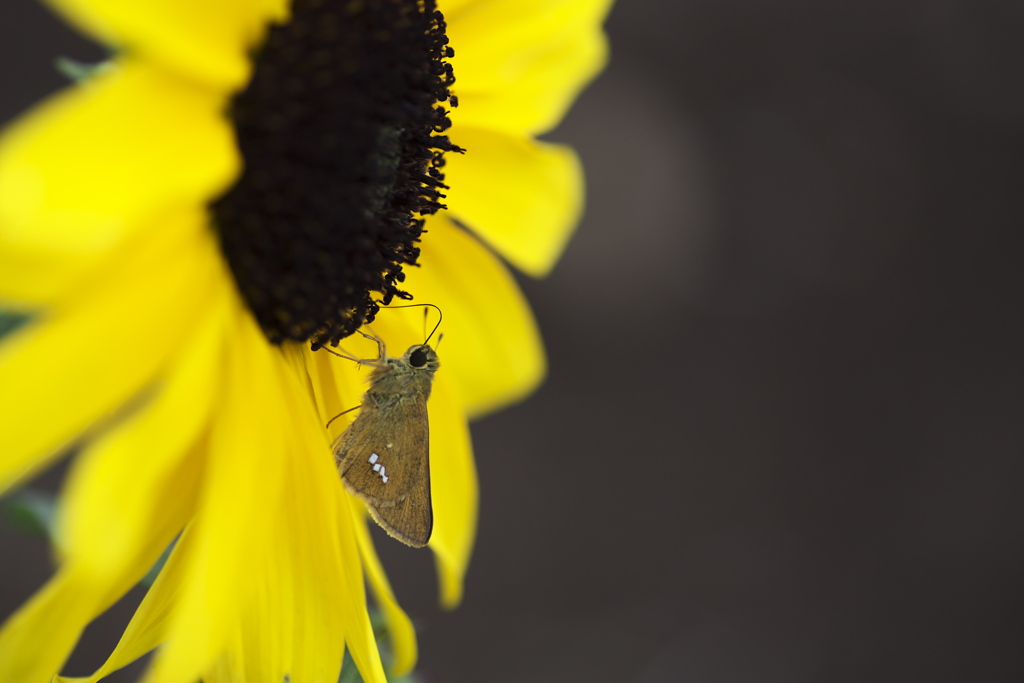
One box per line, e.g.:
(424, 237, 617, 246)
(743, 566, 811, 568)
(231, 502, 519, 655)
(0, 0, 1024, 683)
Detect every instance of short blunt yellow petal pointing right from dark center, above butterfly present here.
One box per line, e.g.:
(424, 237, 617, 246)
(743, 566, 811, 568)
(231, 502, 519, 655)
(444, 128, 584, 276)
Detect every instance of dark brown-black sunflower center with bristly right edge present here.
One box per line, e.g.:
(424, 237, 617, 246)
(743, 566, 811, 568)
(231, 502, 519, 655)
(211, 0, 461, 348)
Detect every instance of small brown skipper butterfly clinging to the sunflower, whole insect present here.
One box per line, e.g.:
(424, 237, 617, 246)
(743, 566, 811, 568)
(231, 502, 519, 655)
(334, 341, 440, 548)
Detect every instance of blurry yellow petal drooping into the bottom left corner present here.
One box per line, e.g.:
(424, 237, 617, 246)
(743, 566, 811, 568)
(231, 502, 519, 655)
(0, 306, 223, 681)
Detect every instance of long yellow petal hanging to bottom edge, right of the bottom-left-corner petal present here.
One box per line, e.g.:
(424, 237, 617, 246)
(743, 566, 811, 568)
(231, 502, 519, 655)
(143, 307, 284, 682)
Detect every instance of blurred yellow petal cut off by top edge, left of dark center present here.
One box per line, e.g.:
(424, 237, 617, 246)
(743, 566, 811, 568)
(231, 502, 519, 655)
(46, 0, 272, 92)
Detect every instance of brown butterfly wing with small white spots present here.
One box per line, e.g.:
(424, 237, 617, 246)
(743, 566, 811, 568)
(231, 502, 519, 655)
(335, 394, 433, 548)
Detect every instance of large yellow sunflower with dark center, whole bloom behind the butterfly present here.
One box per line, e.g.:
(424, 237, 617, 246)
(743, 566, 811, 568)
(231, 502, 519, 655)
(0, 0, 609, 683)
